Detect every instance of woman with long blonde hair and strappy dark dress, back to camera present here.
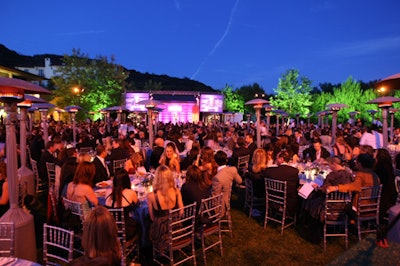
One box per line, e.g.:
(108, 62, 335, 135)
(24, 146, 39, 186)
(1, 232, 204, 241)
(147, 165, 183, 250)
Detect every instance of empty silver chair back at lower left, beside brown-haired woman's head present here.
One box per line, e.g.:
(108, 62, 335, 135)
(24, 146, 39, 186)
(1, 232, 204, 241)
(43, 224, 74, 265)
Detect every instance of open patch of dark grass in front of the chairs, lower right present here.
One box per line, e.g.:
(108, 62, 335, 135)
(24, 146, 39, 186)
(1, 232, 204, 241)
(197, 191, 352, 265)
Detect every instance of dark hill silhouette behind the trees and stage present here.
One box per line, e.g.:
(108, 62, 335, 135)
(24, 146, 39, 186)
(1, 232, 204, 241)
(0, 44, 217, 92)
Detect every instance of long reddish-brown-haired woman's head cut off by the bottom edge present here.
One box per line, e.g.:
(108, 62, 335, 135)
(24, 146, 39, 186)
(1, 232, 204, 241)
(70, 206, 122, 266)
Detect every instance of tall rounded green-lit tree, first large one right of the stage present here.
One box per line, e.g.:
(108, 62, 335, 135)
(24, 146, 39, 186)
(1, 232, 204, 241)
(270, 69, 312, 117)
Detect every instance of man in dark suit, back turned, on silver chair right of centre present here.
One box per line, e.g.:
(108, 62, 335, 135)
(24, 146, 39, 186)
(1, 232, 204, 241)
(264, 151, 299, 217)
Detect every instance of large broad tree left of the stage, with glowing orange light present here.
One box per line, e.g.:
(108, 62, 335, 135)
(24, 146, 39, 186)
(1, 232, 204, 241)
(52, 49, 128, 118)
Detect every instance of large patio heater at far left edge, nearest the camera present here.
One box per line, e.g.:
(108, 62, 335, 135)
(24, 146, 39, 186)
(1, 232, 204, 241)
(0, 78, 50, 261)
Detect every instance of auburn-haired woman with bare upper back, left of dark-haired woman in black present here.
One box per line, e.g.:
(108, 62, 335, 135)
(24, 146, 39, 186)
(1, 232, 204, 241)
(67, 162, 99, 206)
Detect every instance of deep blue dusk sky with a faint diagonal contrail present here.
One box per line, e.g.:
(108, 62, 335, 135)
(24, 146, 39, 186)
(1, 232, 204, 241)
(0, 0, 400, 93)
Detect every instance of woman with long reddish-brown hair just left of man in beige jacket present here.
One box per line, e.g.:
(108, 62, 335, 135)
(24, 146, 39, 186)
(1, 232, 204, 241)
(194, 146, 218, 186)
